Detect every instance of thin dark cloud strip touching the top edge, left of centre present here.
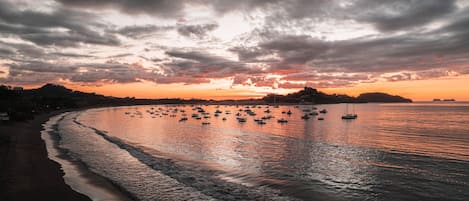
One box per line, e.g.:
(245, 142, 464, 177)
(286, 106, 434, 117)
(58, 0, 184, 17)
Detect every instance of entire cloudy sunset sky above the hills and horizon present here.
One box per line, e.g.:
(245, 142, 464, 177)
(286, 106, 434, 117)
(0, 0, 469, 100)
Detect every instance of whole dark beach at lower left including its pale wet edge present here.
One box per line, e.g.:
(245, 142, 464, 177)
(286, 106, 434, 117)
(0, 110, 131, 201)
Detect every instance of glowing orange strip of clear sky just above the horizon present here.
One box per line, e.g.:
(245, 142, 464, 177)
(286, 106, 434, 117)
(59, 76, 469, 101)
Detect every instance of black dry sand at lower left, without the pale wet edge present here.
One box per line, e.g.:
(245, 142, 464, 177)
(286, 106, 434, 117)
(0, 112, 90, 201)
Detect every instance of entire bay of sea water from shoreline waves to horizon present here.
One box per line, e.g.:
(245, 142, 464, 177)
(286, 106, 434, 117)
(45, 103, 469, 200)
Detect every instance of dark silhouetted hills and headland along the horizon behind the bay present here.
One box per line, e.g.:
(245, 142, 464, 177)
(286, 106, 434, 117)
(0, 84, 412, 120)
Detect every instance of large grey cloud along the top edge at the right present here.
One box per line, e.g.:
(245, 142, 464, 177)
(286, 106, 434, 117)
(256, 0, 458, 33)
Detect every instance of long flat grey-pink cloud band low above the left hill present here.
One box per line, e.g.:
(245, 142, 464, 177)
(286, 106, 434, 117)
(0, 61, 161, 84)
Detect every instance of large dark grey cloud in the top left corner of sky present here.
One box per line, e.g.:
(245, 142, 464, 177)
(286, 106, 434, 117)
(0, 1, 120, 46)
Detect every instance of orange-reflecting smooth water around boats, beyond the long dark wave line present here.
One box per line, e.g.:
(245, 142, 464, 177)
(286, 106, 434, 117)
(78, 103, 469, 200)
